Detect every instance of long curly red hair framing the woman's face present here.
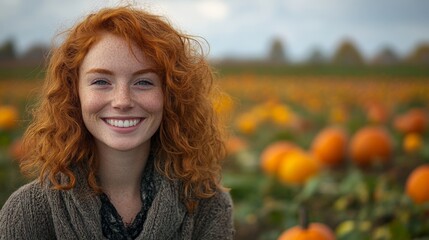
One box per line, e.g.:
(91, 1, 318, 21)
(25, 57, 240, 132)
(21, 7, 226, 210)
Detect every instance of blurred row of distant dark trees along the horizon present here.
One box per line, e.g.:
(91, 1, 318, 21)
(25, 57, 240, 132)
(0, 38, 429, 66)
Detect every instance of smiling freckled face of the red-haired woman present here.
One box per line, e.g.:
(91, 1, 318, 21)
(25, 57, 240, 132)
(79, 34, 163, 151)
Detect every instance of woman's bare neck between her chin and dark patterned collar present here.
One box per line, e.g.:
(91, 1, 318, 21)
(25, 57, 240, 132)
(98, 144, 150, 195)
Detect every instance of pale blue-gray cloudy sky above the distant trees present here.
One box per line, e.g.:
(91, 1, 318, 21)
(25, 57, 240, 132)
(0, 0, 429, 60)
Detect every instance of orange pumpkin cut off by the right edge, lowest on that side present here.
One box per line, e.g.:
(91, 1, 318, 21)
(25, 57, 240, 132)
(405, 164, 429, 204)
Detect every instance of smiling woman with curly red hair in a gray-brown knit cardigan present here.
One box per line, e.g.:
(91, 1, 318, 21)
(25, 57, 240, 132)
(0, 7, 234, 239)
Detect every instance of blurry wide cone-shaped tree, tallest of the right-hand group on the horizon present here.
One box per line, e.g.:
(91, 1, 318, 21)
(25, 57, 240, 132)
(332, 39, 364, 66)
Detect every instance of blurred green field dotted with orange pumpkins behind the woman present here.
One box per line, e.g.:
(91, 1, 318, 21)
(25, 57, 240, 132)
(0, 68, 429, 240)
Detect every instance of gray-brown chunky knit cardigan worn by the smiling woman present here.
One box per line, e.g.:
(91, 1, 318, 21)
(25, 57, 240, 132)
(0, 167, 234, 240)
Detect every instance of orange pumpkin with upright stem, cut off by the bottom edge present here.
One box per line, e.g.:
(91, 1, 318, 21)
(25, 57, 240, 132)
(277, 207, 335, 240)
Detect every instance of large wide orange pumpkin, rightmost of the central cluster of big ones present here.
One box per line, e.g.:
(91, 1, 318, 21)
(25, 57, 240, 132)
(349, 126, 393, 166)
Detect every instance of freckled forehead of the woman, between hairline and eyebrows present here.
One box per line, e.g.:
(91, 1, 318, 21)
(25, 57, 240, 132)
(81, 33, 153, 71)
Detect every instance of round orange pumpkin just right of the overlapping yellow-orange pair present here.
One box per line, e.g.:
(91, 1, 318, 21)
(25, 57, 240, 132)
(311, 127, 348, 167)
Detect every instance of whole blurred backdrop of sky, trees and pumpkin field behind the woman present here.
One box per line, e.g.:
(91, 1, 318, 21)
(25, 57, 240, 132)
(0, 0, 429, 239)
